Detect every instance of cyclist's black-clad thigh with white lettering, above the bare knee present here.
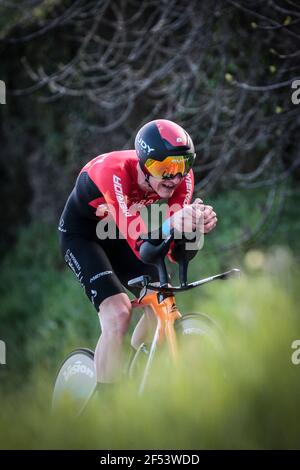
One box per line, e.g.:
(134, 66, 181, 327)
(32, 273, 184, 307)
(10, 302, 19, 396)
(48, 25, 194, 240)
(61, 236, 125, 311)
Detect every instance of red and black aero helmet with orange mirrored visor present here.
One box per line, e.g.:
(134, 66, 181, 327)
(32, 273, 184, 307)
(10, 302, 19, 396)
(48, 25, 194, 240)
(134, 119, 196, 179)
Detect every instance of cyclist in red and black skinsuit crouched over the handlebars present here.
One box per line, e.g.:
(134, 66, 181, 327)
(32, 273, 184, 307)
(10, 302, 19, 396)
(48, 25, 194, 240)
(58, 119, 217, 387)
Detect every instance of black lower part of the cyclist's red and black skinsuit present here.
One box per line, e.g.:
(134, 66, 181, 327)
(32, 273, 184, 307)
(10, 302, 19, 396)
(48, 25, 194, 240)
(58, 193, 158, 311)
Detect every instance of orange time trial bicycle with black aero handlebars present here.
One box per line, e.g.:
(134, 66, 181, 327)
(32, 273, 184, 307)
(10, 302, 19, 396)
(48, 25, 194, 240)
(52, 234, 240, 414)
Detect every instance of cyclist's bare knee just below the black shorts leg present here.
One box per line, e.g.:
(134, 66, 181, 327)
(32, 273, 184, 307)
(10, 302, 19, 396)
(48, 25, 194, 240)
(99, 293, 131, 336)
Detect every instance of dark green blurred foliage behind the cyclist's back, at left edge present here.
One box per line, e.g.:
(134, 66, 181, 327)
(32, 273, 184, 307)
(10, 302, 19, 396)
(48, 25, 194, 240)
(0, 225, 97, 386)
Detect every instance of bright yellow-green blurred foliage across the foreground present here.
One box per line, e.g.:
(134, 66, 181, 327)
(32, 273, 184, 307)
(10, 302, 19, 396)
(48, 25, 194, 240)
(0, 252, 300, 449)
